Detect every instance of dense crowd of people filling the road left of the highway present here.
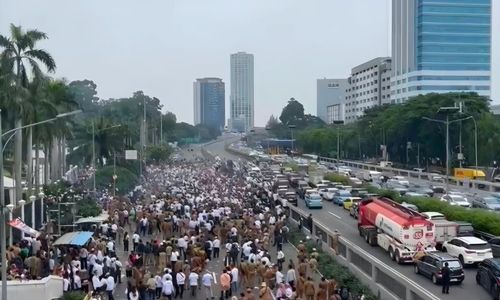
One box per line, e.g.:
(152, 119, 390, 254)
(41, 152, 362, 300)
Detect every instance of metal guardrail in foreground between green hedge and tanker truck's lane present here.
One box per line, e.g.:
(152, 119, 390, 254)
(289, 206, 440, 300)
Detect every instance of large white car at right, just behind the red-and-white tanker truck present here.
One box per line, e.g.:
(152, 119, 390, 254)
(443, 236, 493, 265)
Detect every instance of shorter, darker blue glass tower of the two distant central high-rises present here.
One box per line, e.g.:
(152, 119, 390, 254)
(193, 77, 226, 131)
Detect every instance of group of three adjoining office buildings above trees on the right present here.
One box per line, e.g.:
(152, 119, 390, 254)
(317, 0, 492, 124)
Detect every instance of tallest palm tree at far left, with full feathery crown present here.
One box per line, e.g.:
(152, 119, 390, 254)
(0, 24, 56, 201)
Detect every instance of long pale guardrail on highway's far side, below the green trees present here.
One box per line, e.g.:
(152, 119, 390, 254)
(319, 156, 500, 192)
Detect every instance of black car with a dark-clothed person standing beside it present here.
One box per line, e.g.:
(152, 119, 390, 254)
(415, 253, 465, 284)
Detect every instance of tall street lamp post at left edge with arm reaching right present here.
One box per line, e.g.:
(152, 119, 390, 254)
(0, 109, 82, 299)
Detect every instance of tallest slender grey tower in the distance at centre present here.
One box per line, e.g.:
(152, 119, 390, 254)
(230, 52, 254, 131)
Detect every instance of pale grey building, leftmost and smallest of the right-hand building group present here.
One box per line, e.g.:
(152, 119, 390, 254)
(316, 78, 347, 124)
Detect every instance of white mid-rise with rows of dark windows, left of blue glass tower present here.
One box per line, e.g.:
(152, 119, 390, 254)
(345, 57, 391, 123)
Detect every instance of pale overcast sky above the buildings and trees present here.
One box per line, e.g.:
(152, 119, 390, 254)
(0, 0, 500, 126)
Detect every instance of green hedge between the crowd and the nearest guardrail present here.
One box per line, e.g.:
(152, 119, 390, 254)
(289, 230, 376, 300)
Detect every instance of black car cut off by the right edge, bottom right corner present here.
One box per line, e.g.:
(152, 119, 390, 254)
(476, 258, 500, 300)
